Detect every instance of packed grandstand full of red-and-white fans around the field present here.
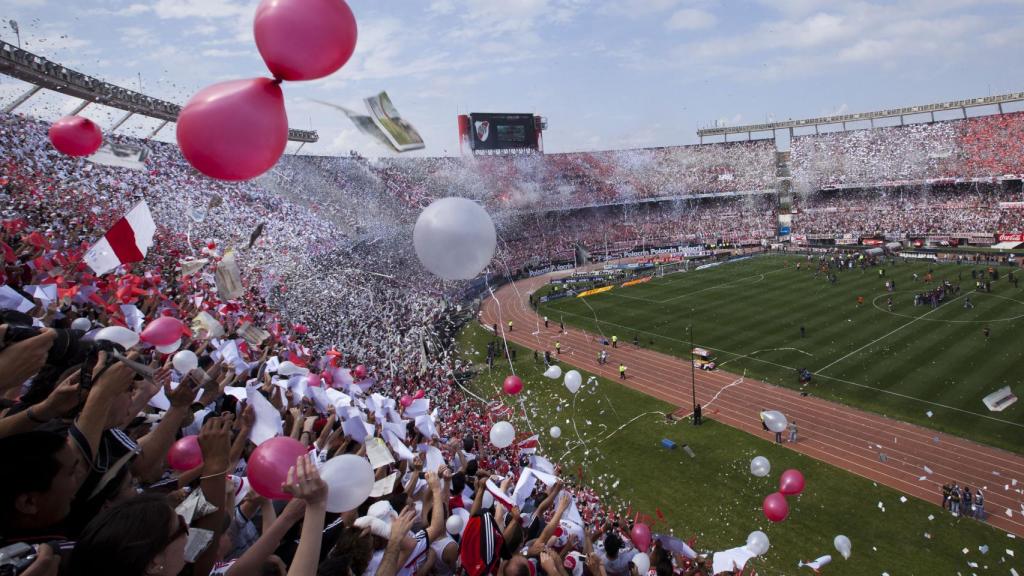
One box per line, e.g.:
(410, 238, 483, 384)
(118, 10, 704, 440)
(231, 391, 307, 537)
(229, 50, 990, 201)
(0, 5, 1024, 576)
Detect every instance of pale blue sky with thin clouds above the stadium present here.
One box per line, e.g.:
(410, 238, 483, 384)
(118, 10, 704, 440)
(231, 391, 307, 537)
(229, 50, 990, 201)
(0, 0, 1024, 156)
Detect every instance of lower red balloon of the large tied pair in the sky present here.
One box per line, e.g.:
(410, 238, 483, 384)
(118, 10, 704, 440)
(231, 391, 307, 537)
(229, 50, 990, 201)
(177, 78, 288, 180)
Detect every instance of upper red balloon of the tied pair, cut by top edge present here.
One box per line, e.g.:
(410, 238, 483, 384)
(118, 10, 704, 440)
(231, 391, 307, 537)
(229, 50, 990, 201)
(253, 0, 357, 80)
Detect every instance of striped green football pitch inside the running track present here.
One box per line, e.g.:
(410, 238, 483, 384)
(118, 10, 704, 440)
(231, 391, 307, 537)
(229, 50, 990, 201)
(540, 255, 1024, 452)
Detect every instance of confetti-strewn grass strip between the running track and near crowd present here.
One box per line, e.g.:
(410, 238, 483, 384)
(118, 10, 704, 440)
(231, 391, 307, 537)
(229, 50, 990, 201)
(459, 325, 1024, 576)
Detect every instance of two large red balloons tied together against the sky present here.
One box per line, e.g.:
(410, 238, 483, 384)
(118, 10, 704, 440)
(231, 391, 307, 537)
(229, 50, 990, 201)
(177, 0, 357, 180)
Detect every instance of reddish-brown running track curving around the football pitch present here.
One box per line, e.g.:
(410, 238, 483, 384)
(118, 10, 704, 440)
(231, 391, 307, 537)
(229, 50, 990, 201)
(481, 270, 1024, 536)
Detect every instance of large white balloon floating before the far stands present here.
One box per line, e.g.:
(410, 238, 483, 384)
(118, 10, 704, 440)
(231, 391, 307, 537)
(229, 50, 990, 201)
(413, 197, 497, 280)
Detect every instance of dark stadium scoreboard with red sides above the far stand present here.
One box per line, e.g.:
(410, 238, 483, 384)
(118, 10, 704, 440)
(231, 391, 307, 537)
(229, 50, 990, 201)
(459, 113, 547, 155)
